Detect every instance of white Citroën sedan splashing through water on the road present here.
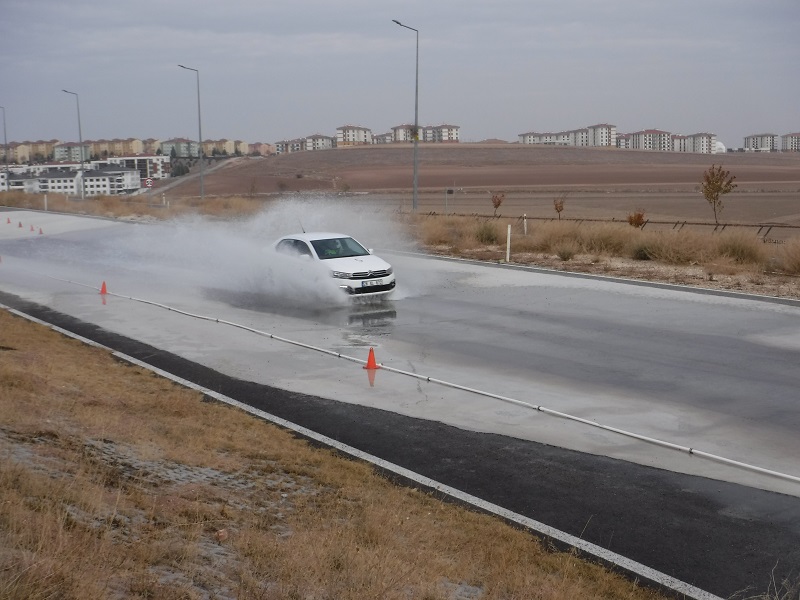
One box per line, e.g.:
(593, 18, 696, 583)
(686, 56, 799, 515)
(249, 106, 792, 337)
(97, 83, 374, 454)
(275, 233, 395, 297)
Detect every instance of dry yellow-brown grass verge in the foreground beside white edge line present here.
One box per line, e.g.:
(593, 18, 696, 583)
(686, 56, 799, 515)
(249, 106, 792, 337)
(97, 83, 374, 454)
(0, 312, 668, 600)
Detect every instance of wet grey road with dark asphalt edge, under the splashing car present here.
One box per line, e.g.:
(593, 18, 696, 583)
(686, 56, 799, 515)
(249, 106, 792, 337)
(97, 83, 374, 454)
(0, 213, 800, 596)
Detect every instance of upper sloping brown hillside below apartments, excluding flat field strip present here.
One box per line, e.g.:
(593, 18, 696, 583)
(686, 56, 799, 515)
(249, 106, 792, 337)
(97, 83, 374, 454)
(162, 144, 800, 196)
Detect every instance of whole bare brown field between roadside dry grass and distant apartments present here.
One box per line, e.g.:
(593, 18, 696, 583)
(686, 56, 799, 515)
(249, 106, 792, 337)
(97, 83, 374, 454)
(166, 144, 800, 226)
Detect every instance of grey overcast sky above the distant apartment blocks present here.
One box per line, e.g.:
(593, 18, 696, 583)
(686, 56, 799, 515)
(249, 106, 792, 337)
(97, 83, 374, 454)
(0, 0, 800, 147)
